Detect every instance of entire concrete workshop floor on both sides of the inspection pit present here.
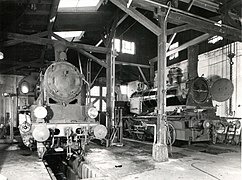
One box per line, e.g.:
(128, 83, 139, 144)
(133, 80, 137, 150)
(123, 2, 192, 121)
(0, 141, 241, 180)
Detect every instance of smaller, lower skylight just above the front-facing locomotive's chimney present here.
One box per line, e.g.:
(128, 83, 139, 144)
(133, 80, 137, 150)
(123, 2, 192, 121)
(52, 31, 85, 42)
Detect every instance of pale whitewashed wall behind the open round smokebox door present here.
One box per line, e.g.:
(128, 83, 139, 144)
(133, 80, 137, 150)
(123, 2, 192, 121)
(198, 42, 242, 117)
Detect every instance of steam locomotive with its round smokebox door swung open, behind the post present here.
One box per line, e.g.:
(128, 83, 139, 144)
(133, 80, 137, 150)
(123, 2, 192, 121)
(123, 67, 233, 144)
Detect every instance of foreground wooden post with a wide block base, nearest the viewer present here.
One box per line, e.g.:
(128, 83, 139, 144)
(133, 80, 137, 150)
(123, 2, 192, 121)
(152, 13, 168, 162)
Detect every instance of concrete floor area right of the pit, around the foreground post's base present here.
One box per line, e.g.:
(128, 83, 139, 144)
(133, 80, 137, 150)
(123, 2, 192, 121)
(86, 141, 241, 180)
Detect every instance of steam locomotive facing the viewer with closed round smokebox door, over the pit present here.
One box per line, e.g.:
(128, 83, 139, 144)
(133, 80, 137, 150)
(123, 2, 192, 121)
(19, 48, 107, 158)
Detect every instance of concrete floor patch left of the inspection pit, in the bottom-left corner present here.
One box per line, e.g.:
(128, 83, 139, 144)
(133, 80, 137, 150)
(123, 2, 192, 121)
(0, 144, 50, 180)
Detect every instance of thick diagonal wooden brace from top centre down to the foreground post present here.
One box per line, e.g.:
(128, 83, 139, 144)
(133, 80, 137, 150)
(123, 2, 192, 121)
(110, 0, 161, 35)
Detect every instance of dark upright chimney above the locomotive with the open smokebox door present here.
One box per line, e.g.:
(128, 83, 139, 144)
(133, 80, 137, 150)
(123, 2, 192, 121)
(188, 45, 199, 80)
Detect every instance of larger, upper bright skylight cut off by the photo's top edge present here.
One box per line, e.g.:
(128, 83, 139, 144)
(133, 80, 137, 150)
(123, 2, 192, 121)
(58, 0, 103, 12)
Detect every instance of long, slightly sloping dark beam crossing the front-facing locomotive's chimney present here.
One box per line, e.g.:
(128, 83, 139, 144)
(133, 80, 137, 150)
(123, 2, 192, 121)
(7, 33, 108, 54)
